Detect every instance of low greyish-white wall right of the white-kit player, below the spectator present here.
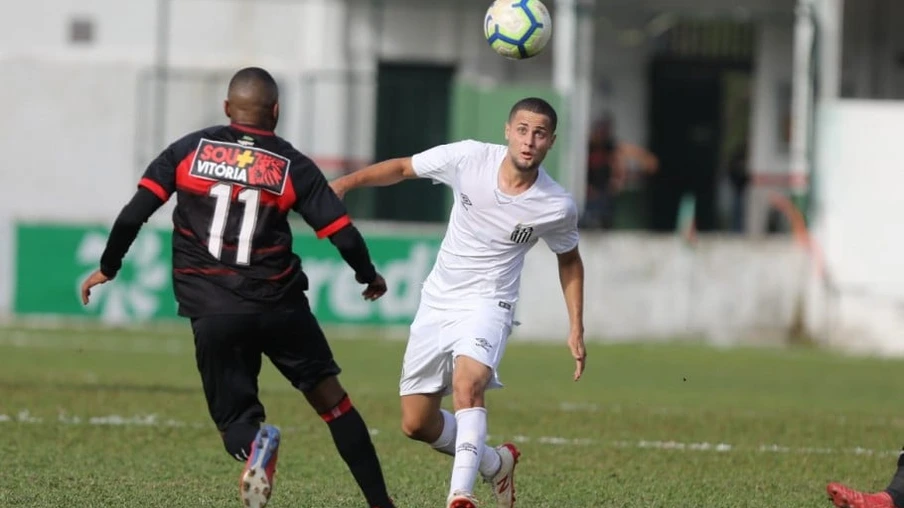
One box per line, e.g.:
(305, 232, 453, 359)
(515, 233, 808, 345)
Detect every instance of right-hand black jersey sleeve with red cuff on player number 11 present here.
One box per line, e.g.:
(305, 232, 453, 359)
(289, 157, 351, 238)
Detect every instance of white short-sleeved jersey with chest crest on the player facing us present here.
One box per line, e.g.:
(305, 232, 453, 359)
(412, 140, 578, 309)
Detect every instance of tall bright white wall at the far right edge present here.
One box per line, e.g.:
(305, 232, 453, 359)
(808, 100, 904, 354)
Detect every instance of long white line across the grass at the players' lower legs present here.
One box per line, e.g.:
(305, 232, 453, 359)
(0, 410, 901, 457)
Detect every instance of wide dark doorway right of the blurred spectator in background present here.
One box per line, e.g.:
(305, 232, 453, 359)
(649, 20, 755, 231)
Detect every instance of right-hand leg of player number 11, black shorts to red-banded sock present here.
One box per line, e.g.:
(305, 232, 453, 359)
(263, 306, 393, 508)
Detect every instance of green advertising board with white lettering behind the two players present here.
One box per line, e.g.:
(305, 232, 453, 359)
(13, 223, 441, 326)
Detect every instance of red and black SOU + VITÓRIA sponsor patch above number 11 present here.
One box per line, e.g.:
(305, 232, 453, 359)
(189, 139, 289, 195)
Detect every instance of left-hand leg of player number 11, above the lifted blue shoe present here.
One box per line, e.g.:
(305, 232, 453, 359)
(192, 316, 265, 462)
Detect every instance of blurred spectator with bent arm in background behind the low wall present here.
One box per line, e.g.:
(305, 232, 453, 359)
(580, 114, 659, 229)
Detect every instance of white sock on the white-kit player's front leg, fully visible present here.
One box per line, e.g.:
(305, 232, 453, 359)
(449, 407, 487, 495)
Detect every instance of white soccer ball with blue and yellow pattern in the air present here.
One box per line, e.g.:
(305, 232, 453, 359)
(483, 0, 552, 60)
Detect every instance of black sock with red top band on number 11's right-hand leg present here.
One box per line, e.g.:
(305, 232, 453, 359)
(320, 396, 393, 508)
